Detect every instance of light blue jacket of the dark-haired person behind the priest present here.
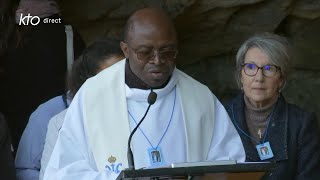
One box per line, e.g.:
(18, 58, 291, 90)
(15, 96, 70, 180)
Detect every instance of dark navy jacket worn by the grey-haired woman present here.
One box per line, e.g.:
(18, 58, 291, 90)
(226, 93, 320, 179)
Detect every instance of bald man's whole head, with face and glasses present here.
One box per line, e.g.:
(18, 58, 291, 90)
(120, 8, 178, 88)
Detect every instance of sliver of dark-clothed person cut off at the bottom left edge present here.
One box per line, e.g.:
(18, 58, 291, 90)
(0, 113, 16, 180)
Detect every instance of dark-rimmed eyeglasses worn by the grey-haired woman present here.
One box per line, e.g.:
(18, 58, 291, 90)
(242, 63, 280, 77)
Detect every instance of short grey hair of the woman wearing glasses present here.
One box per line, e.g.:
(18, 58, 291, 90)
(235, 32, 291, 89)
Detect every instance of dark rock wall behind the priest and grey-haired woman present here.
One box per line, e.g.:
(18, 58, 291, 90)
(58, 0, 320, 120)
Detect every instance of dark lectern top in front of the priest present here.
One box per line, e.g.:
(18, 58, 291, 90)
(117, 162, 275, 180)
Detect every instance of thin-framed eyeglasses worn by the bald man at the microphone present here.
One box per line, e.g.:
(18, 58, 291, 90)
(128, 46, 178, 62)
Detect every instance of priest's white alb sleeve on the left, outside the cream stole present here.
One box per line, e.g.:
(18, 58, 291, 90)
(44, 89, 118, 180)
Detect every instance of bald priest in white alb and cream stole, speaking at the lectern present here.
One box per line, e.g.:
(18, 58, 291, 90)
(44, 8, 245, 180)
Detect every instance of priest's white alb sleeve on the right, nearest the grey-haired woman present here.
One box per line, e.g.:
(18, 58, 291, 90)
(208, 97, 246, 162)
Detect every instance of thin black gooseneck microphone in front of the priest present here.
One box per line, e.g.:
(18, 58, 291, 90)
(127, 89, 157, 170)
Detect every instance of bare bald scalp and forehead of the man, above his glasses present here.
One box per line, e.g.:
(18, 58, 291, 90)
(124, 8, 176, 42)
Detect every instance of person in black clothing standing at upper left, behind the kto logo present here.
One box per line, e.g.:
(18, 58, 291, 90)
(2, 0, 85, 149)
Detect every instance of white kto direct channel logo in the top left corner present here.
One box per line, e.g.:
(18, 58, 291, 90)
(19, 13, 61, 26)
